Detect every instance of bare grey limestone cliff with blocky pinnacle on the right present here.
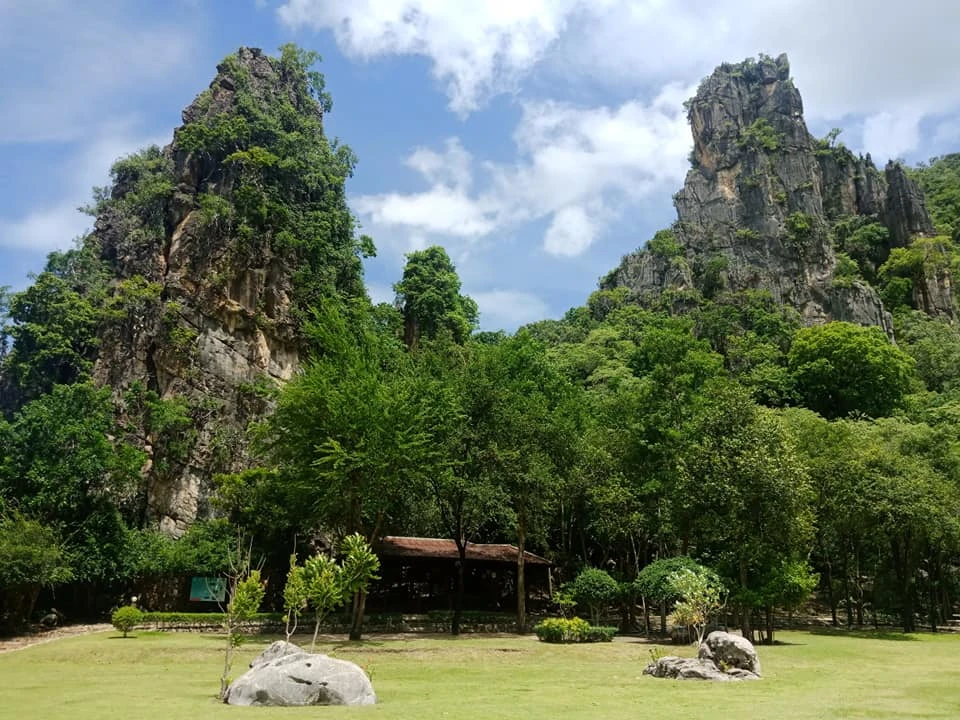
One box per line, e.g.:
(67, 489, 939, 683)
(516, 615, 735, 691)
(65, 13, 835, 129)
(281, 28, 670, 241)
(602, 55, 933, 335)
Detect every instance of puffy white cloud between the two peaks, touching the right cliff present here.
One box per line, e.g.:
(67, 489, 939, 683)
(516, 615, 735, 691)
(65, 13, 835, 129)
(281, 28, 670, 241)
(354, 85, 691, 257)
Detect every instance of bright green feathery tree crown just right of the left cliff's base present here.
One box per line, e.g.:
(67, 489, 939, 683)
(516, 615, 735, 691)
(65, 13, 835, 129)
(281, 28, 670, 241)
(261, 307, 431, 540)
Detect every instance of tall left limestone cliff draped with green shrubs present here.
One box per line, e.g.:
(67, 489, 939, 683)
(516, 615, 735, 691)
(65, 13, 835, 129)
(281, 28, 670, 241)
(94, 48, 363, 535)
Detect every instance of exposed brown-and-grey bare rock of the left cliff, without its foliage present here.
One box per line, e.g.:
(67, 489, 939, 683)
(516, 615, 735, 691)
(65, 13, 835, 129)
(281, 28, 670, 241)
(94, 49, 300, 535)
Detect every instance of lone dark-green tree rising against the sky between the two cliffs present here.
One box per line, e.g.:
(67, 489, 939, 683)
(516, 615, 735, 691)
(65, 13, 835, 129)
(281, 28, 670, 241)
(393, 245, 477, 348)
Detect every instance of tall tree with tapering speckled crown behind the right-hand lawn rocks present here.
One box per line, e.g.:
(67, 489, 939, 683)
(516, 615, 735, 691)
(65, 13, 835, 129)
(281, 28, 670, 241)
(672, 384, 814, 642)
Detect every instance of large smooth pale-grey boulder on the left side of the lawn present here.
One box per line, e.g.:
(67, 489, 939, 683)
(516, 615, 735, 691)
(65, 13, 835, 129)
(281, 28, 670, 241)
(224, 641, 377, 706)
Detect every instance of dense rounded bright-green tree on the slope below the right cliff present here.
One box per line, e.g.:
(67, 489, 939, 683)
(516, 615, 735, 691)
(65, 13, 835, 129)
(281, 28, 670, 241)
(788, 322, 914, 418)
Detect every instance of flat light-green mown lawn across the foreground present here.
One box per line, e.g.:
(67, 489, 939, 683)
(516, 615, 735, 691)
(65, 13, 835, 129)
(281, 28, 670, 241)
(0, 632, 960, 720)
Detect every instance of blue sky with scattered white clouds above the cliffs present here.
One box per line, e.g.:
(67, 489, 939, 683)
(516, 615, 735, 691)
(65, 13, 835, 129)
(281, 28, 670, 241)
(0, 0, 960, 329)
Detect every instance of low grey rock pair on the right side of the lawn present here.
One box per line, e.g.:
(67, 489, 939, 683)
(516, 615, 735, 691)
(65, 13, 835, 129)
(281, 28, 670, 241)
(643, 631, 761, 682)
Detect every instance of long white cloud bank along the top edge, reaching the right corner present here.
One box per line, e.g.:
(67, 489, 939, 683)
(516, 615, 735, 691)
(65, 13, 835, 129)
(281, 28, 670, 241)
(278, 0, 960, 159)
